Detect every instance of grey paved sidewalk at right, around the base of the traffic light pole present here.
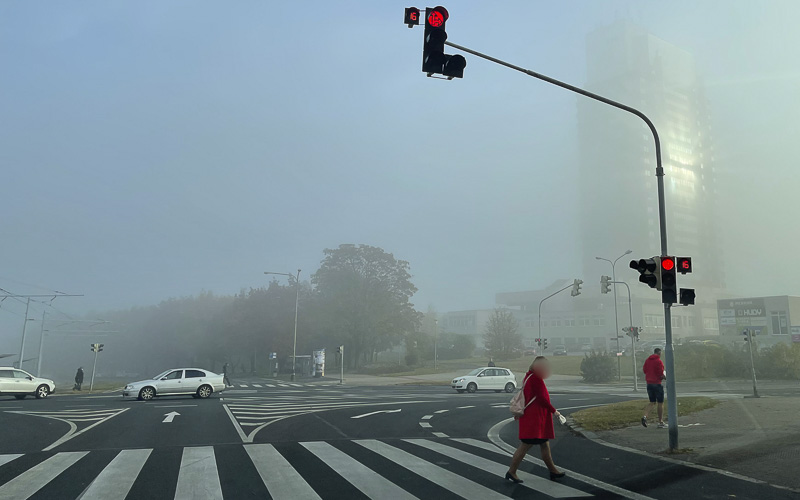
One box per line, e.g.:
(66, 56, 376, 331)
(587, 397, 800, 489)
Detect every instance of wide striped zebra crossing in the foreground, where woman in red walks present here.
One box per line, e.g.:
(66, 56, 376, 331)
(0, 438, 609, 500)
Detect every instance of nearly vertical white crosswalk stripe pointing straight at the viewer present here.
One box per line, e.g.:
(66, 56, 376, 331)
(175, 446, 222, 500)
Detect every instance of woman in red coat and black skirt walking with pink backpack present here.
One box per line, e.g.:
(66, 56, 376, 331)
(506, 356, 565, 483)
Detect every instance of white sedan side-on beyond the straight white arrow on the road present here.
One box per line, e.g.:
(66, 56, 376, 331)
(122, 368, 225, 401)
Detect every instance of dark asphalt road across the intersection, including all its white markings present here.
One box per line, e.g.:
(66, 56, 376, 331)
(0, 380, 798, 500)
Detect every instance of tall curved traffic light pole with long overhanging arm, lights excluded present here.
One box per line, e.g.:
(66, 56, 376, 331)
(444, 41, 678, 450)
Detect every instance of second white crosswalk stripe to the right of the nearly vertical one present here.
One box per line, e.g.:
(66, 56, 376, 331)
(301, 441, 417, 500)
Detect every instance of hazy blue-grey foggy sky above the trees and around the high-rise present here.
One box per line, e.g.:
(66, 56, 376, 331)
(0, 0, 800, 344)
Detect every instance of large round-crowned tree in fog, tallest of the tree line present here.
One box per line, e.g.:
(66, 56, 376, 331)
(311, 244, 420, 367)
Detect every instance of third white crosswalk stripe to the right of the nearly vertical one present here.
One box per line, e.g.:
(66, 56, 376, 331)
(354, 439, 508, 500)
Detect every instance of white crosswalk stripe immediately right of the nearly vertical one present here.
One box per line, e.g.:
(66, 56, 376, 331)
(244, 444, 320, 500)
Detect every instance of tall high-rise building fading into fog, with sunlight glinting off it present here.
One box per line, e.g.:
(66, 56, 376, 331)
(578, 21, 724, 292)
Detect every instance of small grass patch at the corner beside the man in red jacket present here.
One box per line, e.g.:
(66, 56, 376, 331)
(572, 396, 720, 431)
